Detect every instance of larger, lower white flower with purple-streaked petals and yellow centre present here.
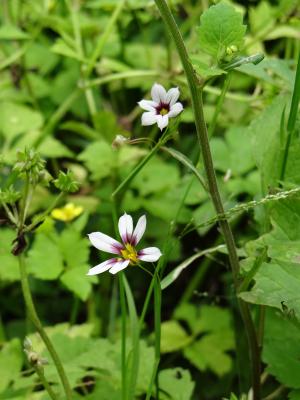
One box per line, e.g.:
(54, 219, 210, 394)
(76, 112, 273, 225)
(88, 213, 162, 275)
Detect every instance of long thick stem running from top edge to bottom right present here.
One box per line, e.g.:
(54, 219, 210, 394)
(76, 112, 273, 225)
(155, 0, 260, 400)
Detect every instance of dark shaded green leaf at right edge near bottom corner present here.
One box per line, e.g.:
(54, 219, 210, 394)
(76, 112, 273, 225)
(262, 310, 300, 388)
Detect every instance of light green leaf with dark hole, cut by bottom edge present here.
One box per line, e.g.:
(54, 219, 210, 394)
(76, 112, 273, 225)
(159, 368, 195, 400)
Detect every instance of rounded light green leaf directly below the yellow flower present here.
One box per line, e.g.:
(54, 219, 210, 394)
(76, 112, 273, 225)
(27, 233, 64, 280)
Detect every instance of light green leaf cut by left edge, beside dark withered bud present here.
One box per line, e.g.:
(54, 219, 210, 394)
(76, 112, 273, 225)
(0, 228, 20, 282)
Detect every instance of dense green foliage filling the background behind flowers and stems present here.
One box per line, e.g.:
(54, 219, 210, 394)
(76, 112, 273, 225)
(0, 0, 300, 400)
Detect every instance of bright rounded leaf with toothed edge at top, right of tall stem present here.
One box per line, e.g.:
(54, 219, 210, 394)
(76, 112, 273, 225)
(199, 2, 246, 60)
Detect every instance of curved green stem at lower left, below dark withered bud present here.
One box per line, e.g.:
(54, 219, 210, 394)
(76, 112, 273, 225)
(18, 253, 72, 400)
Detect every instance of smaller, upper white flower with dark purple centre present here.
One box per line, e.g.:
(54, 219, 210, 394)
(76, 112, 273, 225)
(138, 83, 183, 131)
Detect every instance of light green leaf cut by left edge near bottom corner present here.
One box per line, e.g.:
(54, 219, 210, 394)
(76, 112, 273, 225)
(0, 339, 23, 392)
